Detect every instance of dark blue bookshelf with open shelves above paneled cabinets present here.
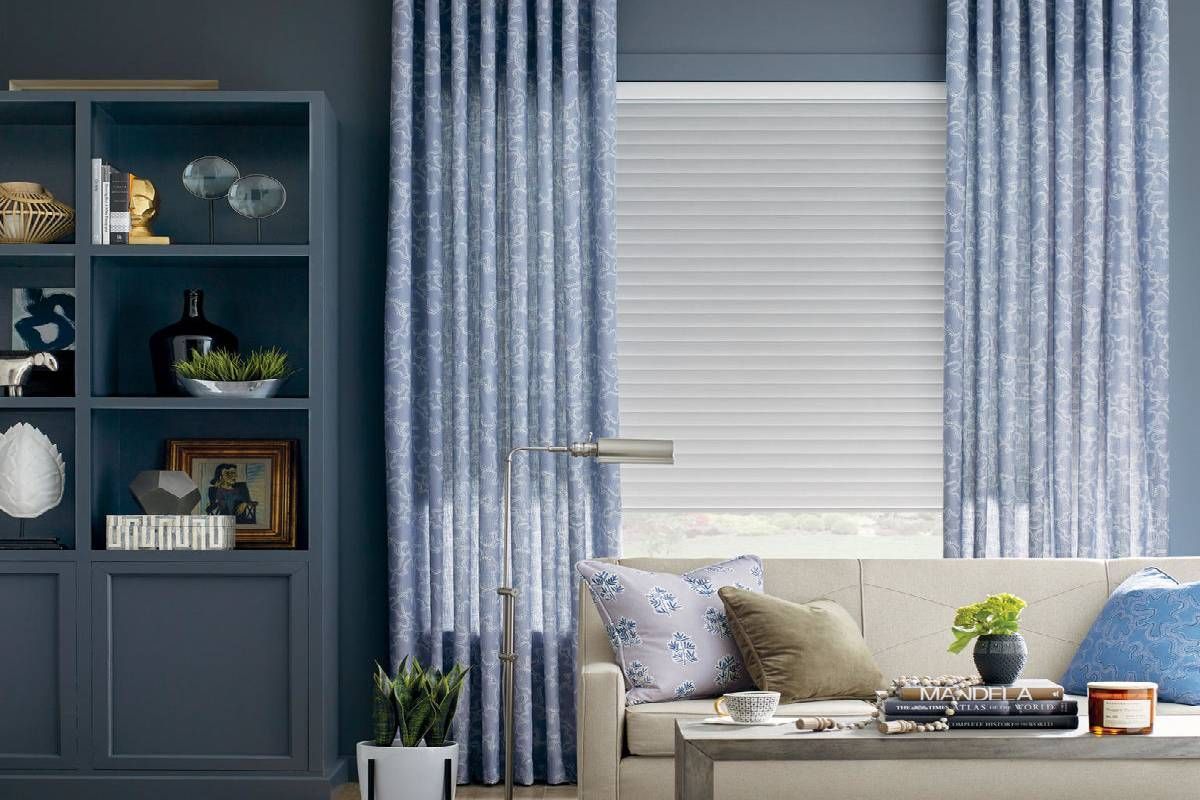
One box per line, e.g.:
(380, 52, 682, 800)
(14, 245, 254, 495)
(0, 91, 346, 800)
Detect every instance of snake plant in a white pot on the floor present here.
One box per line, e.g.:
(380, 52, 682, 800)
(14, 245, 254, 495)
(358, 657, 467, 800)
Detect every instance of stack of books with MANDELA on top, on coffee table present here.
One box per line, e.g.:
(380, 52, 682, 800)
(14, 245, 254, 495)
(883, 679, 1079, 730)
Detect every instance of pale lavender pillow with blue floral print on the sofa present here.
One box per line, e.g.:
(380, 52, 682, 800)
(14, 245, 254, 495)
(575, 555, 762, 705)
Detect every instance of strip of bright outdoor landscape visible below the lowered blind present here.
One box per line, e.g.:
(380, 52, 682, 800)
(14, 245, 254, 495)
(622, 511, 942, 558)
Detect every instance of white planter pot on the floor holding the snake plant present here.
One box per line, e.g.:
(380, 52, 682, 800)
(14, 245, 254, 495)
(358, 741, 458, 800)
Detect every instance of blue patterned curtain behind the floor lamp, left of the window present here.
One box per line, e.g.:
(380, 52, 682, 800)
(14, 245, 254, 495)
(384, 0, 619, 783)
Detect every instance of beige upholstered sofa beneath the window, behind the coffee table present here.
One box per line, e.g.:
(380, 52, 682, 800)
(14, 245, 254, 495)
(577, 558, 1200, 800)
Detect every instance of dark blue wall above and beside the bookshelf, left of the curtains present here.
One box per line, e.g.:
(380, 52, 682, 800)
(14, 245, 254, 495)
(0, 0, 391, 752)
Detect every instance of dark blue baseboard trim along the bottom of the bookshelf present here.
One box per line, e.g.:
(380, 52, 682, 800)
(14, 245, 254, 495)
(0, 777, 346, 800)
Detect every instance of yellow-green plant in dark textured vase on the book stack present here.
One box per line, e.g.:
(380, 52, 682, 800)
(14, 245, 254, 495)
(949, 594, 1028, 685)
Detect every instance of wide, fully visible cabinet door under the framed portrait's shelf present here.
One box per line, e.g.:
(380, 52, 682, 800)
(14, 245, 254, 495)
(92, 561, 308, 770)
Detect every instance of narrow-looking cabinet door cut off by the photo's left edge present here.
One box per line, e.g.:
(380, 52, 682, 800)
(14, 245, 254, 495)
(0, 563, 77, 769)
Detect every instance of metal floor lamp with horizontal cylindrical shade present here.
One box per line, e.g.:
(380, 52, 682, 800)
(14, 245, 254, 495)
(496, 439, 674, 800)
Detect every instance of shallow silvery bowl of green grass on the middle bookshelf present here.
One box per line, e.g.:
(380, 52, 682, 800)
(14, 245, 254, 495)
(173, 348, 295, 399)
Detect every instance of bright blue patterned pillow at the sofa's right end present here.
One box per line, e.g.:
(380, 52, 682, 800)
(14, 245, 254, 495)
(1062, 567, 1200, 705)
